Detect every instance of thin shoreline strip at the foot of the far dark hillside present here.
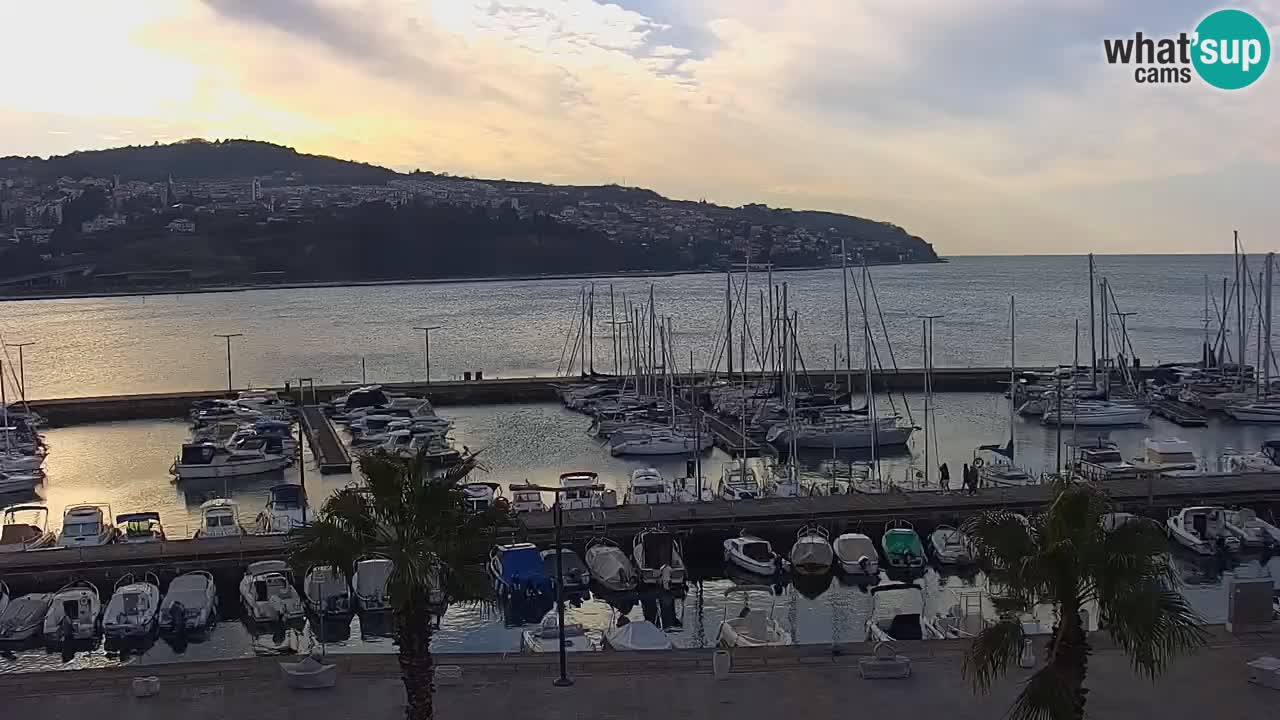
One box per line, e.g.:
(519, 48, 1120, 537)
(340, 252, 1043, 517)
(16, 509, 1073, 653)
(0, 258, 948, 302)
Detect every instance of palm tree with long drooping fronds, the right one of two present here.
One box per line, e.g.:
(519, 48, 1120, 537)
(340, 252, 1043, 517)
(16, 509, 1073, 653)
(964, 480, 1207, 720)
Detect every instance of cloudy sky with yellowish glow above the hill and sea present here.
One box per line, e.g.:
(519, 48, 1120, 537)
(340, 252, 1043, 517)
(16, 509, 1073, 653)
(0, 0, 1280, 255)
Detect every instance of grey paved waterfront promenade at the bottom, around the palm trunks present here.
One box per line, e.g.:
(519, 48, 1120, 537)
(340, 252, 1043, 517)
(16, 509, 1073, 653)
(0, 633, 1280, 720)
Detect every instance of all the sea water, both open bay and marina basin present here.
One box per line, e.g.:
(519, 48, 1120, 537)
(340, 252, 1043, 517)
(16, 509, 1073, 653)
(0, 256, 1280, 673)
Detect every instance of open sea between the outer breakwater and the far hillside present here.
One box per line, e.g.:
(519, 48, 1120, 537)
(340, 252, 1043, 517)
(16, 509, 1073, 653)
(0, 255, 1261, 397)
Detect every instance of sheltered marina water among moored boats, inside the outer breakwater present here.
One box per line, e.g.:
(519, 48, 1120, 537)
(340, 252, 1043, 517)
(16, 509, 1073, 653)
(0, 393, 1280, 673)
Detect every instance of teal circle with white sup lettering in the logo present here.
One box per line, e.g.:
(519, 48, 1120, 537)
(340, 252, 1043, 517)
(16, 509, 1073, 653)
(1192, 10, 1271, 90)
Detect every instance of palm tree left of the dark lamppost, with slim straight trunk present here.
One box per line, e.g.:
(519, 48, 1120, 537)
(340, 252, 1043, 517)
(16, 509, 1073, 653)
(289, 452, 500, 720)
